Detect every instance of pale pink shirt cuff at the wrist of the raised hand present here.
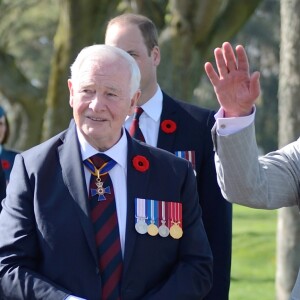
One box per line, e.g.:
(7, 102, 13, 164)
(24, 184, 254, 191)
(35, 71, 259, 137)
(215, 106, 256, 135)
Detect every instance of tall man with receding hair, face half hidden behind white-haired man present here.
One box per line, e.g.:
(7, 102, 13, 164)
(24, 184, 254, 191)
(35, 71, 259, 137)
(105, 14, 232, 300)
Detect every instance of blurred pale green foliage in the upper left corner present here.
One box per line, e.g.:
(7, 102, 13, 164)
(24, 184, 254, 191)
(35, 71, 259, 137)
(0, 0, 59, 87)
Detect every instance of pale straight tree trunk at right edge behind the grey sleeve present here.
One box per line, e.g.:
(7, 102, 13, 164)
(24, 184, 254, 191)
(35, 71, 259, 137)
(276, 0, 300, 300)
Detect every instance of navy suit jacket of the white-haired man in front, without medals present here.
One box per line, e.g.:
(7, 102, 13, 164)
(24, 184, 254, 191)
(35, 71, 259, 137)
(0, 119, 212, 300)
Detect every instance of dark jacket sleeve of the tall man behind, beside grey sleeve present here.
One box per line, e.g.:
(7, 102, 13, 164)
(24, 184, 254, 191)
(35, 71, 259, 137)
(197, 113, 232, 300)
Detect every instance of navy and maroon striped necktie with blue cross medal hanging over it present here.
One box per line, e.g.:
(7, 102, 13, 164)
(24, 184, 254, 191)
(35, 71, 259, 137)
(84, 154, 122, 300)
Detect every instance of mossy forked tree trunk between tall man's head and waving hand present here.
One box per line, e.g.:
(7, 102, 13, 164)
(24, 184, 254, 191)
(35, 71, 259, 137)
(158, 0, 261, 102)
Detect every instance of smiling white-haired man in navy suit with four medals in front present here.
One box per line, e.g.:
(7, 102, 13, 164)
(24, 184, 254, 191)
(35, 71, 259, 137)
(0, 45, 212, 300)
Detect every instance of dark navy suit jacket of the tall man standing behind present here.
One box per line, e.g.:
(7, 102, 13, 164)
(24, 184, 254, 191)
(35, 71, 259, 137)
(157, 93, 232, 300)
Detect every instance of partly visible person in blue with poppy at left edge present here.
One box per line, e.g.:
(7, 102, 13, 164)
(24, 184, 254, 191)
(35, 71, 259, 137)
(0, 106, 18, 183)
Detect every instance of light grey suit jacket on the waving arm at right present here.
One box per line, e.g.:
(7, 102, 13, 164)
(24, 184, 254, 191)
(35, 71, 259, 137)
(212, 124, 300, 300)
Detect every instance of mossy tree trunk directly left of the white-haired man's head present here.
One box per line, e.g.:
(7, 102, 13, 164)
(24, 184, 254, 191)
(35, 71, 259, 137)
(43, 0, 119, 140)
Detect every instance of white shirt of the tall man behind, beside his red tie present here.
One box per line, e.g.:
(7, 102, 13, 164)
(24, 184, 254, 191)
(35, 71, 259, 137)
(125, 86, 163, 147)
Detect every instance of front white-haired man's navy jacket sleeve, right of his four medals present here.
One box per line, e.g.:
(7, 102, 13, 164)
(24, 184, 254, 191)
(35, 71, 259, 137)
(143, 163, 212, 300)
